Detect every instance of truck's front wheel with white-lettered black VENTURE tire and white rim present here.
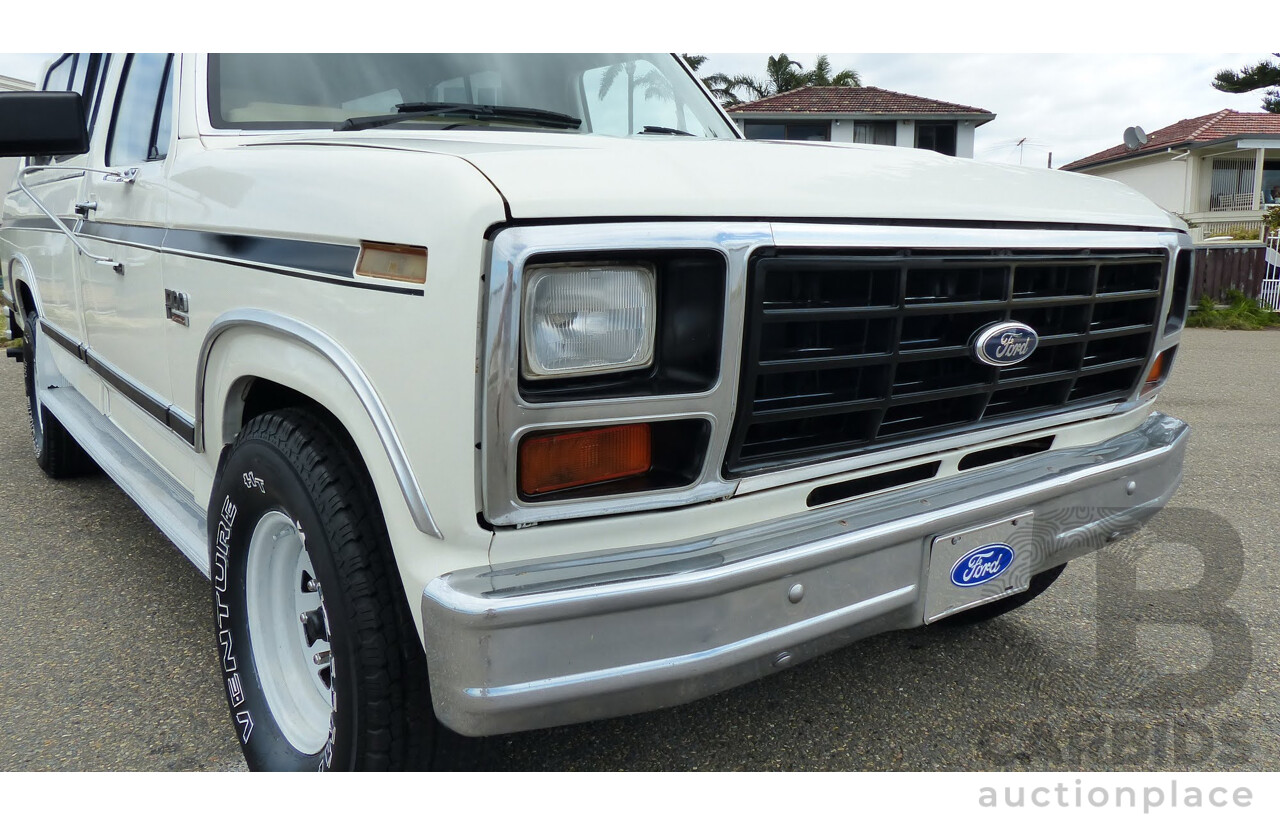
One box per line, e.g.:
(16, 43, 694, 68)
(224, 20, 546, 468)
(209, 409, 436, 770)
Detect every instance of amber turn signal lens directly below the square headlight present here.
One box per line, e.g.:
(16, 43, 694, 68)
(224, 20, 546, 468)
(520, 423, 653, 495)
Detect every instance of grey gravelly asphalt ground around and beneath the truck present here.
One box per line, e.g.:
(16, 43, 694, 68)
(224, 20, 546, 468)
(0, 330, 1280, 771)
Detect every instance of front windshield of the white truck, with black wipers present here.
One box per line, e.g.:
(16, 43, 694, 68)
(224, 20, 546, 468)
(209, 54, 733, 137)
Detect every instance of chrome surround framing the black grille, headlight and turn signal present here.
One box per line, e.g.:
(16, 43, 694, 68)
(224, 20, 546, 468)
(476, 220, 1190, 526)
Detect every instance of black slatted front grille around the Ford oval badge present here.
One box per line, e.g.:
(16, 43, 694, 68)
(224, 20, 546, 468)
(724, 249, 1167, 476)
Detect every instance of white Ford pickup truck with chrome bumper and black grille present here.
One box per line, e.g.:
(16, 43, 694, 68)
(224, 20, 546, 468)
(0, 54, 1190, 769)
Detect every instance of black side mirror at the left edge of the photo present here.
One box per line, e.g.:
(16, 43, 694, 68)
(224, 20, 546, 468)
(0, 92, 88, 157)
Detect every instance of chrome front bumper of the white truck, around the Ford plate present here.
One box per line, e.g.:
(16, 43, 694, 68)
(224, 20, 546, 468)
(422, 413, 1189, 735)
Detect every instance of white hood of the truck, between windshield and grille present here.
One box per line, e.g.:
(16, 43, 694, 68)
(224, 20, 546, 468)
(254, 130, 1184, 229)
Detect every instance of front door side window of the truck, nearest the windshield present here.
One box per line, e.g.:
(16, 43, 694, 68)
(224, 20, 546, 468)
(106, 54, 173, 166)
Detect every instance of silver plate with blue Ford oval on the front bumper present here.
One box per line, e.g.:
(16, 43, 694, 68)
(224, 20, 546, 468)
(924, 510, 1036, 623)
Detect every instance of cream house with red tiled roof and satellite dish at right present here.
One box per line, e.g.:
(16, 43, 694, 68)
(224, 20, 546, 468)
(1062, 109, 1280, 242)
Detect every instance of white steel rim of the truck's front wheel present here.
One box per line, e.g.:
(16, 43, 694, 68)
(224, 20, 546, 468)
(244, 510, 334, 753)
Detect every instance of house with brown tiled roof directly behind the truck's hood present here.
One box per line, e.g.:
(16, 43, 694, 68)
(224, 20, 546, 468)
(727, 86, 996, 157)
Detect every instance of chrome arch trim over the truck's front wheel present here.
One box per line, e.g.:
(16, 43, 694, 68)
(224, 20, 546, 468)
(195, 310, 444, 538)
